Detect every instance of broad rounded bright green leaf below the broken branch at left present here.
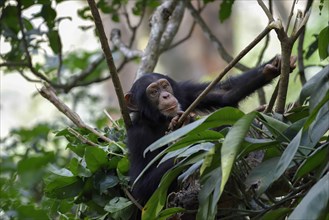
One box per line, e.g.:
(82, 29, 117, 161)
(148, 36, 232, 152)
(85, 147, 108, 173)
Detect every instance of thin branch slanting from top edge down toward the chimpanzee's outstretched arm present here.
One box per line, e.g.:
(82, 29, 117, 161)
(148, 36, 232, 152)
(185, 0, 250, 71)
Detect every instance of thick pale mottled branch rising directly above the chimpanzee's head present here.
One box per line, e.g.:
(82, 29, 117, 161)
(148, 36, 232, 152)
(136, 0, 178, 79)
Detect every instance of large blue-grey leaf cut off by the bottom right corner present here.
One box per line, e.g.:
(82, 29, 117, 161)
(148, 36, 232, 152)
(288, 173, 329, 220)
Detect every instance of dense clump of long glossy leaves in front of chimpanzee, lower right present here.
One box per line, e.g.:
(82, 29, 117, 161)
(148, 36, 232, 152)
(141, 66, 329, 219)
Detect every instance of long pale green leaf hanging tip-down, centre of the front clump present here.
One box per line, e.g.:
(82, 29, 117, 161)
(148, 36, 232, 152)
(220, 112, 256, 192)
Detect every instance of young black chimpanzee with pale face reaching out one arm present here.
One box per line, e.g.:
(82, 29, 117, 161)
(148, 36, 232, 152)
(125, 57, 295, 205)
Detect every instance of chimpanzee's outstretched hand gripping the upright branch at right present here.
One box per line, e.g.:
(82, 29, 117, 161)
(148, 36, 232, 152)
(263, 56, 297, 80)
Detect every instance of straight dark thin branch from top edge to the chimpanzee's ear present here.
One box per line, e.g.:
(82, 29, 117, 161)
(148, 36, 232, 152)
(88, 0, 131, 129)
